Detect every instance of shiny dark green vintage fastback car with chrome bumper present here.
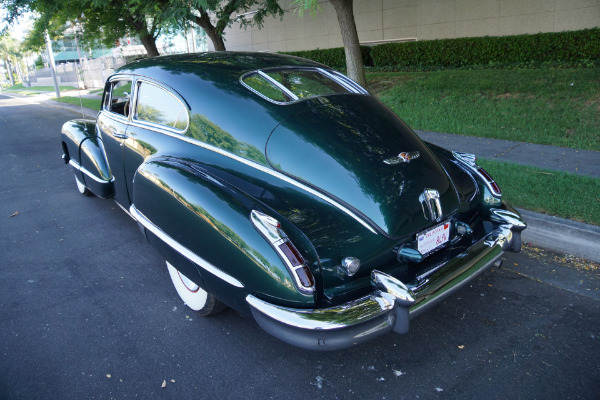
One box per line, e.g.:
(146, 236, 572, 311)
(61, 52, 526, 350)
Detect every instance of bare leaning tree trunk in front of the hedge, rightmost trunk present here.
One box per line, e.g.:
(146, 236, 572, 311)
(330, 0, 367, 86)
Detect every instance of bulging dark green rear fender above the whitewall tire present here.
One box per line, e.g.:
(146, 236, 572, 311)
(130, 157, 318, 312)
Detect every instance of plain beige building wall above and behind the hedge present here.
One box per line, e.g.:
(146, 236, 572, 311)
(219, 0, 600, 51)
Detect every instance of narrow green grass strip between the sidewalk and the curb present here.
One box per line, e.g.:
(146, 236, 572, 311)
(477, 158, 600, 226)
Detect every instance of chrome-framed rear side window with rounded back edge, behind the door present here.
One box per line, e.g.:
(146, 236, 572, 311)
(135, 82, 189, 131)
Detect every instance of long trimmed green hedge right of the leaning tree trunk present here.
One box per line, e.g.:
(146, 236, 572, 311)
(371, 28, 600, 68)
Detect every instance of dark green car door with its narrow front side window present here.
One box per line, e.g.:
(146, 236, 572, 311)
(96, 76, 132, 209)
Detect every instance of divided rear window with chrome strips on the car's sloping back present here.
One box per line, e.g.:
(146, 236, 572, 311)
(241, 68, 367, 103)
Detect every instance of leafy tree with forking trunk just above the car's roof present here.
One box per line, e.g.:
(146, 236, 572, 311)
(184, 0, 285, 51)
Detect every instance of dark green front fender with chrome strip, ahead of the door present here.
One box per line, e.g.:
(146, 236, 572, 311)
(61, 119, 114, 198)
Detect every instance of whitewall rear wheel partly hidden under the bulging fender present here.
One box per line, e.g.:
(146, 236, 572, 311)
(167, 261, 226, 317)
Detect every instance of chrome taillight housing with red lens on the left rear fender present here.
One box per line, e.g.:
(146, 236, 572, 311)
(250, 210, 315, 293)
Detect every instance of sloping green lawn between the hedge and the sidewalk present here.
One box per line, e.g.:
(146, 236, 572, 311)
(367, 68, 600, 151)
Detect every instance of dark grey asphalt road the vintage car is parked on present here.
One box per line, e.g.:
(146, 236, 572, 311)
(0, 94, 600, 400)
